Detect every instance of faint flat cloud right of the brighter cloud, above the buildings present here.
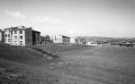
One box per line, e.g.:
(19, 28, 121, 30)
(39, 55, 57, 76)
(31, 16, 63, 24)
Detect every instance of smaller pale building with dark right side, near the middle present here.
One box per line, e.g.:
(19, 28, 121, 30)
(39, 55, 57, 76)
(51, 35, 70, 44)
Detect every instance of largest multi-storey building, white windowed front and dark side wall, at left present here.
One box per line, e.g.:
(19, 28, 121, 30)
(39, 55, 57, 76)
(4, 26, 40, 46)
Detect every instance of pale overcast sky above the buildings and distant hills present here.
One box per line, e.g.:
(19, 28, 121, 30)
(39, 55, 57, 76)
(0, 0, 135, 37)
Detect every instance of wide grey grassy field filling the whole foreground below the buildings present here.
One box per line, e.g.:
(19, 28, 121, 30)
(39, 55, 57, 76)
(0, 45, 135, 84)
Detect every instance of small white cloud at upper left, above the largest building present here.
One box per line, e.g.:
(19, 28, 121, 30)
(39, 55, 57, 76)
(5, 10, 26, 19)
